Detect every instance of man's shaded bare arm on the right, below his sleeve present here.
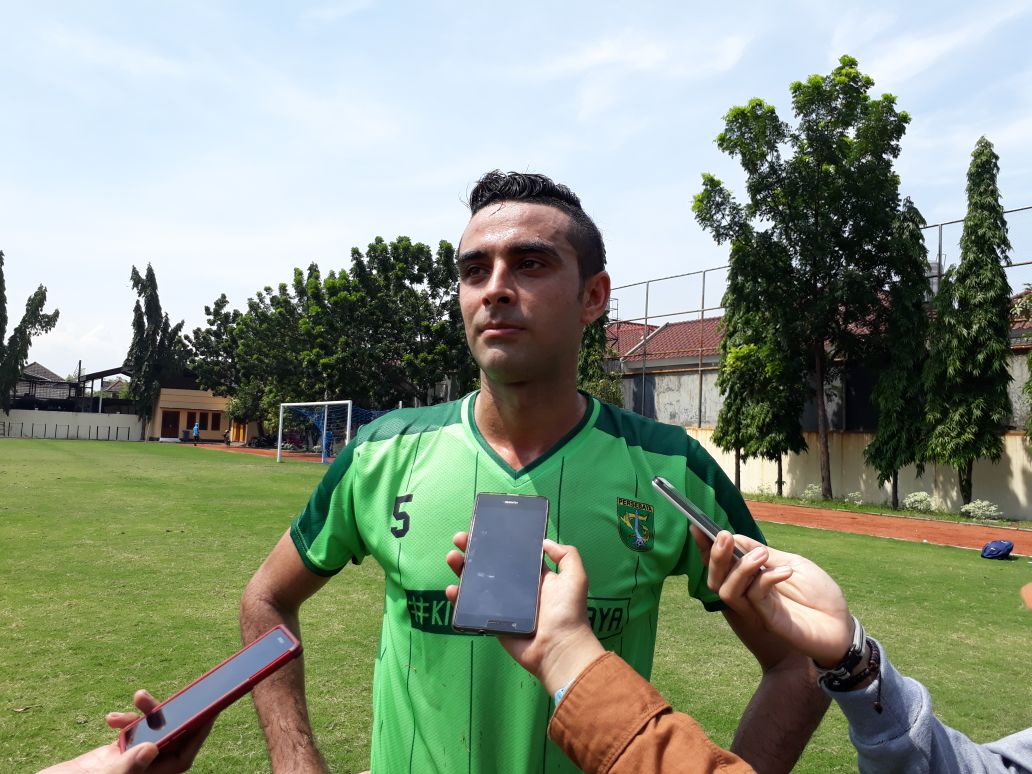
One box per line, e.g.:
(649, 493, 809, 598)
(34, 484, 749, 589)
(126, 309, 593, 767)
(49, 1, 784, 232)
(723, 610, 830, 774)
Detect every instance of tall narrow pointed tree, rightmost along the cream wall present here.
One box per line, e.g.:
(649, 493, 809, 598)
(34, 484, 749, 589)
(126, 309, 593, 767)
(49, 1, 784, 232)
(927, 137, 1011, 504)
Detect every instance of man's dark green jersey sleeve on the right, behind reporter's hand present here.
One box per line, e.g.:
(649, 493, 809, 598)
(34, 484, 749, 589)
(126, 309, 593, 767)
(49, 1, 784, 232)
(674, 433, 767, 611)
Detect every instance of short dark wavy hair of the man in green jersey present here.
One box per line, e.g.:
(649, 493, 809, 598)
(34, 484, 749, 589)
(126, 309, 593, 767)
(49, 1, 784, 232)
(470, 169, 606, 282)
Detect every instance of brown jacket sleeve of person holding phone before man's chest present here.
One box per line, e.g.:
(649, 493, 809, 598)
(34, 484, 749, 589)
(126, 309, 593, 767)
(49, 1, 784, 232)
(548, 653, 754, 774)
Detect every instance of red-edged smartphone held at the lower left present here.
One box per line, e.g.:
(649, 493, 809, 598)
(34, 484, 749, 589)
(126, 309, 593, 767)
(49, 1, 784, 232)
(119, 625, 301, 750)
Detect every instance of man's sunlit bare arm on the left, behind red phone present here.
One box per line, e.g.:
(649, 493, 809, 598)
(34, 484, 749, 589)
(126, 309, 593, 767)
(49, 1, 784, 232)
(240, 533, 328, 774)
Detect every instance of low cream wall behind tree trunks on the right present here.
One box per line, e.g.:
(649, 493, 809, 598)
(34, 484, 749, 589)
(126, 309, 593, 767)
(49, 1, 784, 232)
(687, 427, 1032, 519)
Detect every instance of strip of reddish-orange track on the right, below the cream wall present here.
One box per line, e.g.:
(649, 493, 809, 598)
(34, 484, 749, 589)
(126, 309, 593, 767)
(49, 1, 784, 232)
(748, 499, 1032, 556)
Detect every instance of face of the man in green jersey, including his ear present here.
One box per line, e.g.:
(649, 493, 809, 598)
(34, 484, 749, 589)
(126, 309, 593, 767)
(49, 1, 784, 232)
(458, 201, 609, 384)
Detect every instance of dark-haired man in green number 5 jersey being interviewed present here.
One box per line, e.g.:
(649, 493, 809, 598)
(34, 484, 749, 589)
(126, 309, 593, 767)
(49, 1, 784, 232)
(240, 172, 827, 774)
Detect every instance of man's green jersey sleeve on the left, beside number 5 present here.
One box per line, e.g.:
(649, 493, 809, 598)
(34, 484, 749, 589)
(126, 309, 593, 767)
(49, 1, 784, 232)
(290, 434, 368, 577)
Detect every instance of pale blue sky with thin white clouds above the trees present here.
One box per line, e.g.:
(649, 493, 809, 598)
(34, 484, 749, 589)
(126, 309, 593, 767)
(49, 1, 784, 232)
(0, 0, 1032, 376)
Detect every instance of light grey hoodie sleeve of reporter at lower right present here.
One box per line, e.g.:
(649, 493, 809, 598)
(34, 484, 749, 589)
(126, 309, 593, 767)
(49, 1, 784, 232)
(826, 643, 1032, 774)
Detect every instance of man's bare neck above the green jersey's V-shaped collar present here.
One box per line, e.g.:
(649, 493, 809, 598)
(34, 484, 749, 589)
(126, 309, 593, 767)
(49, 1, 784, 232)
(473, 373, 588, 471)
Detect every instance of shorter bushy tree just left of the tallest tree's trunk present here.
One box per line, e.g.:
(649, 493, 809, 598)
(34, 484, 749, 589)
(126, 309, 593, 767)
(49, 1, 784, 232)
(699, 233, 806, 496)
